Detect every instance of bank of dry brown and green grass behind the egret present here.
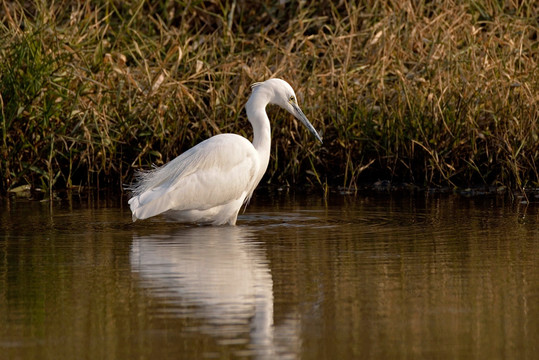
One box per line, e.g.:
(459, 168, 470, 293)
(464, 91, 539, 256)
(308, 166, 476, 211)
(0, 0, 539, 193)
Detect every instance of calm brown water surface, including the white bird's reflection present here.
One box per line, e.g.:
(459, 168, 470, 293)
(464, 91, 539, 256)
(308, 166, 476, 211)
(0, 191, 539, 359)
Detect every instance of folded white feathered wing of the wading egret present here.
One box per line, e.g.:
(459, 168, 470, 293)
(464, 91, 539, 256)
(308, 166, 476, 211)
(129, 134, 260, 219)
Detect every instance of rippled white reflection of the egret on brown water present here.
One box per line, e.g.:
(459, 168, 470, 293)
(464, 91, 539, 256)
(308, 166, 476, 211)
(130, 227, 297, 356)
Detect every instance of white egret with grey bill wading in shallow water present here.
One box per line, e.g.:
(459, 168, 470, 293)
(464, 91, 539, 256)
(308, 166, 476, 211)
(129, 79, 322, 225)
